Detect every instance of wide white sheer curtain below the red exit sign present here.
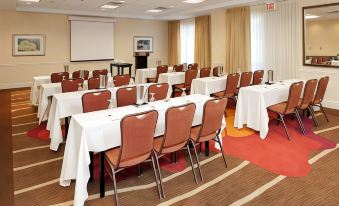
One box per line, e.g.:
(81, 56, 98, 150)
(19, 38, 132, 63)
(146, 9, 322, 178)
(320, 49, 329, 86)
(251, 0, 302, 79)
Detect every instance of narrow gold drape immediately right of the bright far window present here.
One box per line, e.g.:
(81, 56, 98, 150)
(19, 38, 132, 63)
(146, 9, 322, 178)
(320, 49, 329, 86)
(194, 16, 211, 68)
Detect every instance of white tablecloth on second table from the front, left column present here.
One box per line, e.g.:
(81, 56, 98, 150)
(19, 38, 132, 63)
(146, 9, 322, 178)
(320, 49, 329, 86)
(47, 84, 155, 151)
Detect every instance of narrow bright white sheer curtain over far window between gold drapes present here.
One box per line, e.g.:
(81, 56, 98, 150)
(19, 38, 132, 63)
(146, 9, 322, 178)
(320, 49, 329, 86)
(180, 19, 195, 64)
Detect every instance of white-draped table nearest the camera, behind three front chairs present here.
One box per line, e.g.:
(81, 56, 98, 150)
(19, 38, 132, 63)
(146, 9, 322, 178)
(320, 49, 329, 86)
(60, 94, 226, 206)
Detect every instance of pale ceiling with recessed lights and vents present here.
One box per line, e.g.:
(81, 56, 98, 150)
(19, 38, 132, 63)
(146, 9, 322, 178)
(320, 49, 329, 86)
(15, 0, 265, 20)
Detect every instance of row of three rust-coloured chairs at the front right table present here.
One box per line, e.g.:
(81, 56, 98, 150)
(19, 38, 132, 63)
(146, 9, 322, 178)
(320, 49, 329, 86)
(268, 77, 329, 140)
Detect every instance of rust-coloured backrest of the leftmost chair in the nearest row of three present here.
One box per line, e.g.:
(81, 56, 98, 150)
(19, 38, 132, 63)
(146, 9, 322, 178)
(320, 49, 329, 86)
(117, 110, 158, 167)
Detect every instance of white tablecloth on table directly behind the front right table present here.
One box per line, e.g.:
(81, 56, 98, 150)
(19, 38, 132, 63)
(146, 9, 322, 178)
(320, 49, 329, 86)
(191, 76, 227, 96)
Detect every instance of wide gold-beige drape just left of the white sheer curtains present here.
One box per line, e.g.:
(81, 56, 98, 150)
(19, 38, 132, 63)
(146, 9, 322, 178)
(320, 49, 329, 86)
(226, 7, 251, 73)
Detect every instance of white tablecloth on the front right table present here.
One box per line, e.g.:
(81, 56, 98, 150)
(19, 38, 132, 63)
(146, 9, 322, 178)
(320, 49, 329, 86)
(234, 79, 300, 139)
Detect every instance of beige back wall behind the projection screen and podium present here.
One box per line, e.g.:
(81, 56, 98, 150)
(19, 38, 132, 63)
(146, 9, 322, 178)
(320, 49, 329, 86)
(0, 11, 168, 89)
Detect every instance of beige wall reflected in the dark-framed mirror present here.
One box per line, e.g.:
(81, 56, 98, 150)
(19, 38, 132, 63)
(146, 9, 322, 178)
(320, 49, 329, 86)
(305, 19, 339, 56)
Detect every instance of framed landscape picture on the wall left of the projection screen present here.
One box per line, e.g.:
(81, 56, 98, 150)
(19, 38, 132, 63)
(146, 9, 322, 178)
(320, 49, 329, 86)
(13, 34, 46, 56)
